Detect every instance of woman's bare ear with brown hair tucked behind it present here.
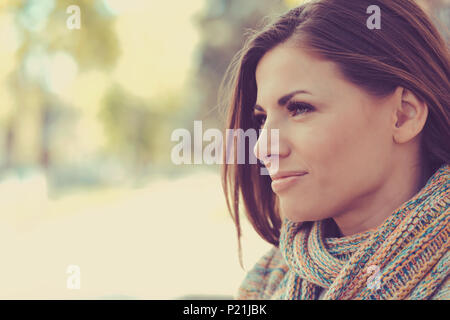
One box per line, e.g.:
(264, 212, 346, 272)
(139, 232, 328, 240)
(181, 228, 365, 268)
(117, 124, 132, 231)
(392, 87, 428, 143)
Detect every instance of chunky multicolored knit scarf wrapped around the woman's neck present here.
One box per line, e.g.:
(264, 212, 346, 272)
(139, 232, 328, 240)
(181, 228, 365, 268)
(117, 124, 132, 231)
(237, 165, 450, 300)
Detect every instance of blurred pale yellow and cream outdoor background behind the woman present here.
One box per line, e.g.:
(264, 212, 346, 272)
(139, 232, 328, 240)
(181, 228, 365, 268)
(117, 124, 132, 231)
(0, 0, 450, 299)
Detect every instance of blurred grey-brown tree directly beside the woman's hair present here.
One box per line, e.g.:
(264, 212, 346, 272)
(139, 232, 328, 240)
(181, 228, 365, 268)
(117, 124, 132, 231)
(189, 0, 287, 128)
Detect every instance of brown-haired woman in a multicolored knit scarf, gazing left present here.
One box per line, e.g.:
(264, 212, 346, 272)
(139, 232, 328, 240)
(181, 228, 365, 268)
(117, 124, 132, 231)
(221, 0, 450, 299)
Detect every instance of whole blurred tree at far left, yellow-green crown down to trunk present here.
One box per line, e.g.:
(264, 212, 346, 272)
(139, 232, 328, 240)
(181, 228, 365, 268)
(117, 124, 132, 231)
(5, 0, 119, 172)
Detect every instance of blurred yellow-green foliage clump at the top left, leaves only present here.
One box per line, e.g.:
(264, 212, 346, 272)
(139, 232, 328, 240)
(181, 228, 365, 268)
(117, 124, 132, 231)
(18, 0, 119, 71)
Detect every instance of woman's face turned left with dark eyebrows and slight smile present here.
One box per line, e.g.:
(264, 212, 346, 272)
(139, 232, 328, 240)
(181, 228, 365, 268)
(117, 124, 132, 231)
(255, 45, 400, 222)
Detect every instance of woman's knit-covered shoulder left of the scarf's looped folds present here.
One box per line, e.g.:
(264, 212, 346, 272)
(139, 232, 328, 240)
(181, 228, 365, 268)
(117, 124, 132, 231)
(236, 246, 289, 300)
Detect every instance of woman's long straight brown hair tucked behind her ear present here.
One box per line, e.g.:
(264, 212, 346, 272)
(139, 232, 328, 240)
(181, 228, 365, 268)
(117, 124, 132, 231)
(219, 0, 450, 266)
